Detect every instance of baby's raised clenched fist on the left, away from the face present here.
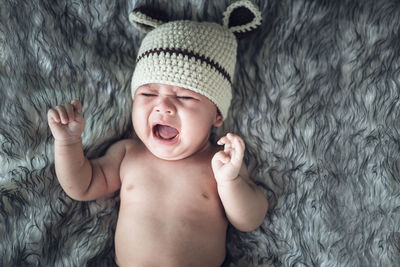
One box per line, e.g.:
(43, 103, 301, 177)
(47, 100, 85, 145)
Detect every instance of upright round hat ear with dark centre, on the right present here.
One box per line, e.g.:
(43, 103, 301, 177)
(223, 0, 262, 39)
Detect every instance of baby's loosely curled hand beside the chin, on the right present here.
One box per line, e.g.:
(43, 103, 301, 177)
(211, 133, 245, 183)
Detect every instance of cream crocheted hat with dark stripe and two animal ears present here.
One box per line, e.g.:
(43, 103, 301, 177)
(129, 0, 261, 119)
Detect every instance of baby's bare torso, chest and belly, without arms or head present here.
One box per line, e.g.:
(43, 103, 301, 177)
(115, 148, 227, 266)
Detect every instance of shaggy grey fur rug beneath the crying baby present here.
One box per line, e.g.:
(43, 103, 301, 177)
(0, 0, 400, 266)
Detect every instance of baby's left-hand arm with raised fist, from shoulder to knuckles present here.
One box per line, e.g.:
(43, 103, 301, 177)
(47, 100, 125, 201)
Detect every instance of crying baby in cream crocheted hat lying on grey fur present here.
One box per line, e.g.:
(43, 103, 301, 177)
(48, 1, 268, 267)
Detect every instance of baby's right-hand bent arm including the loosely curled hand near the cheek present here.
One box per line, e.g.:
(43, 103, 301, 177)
(212, 133, 268, 232)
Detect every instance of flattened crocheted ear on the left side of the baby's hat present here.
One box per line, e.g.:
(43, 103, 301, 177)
(129, 6, 169, 33)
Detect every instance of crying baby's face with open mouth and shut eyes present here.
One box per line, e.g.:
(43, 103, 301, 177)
(132, 83, 222, 160)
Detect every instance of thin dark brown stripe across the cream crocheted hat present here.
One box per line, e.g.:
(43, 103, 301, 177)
(136, 48, 232, 84)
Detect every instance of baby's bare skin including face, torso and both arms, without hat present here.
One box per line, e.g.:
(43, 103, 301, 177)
(48, 84, 268, 266)
